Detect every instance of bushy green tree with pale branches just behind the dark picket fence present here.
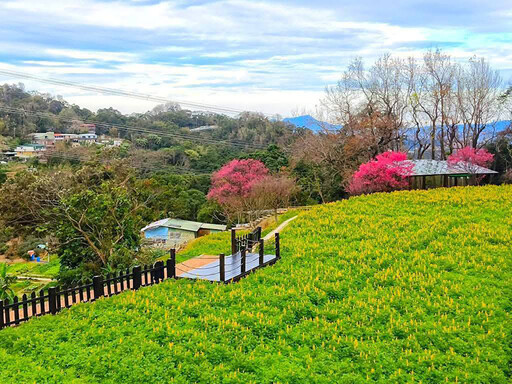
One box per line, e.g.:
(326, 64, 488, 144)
(54, 182, 144, 280)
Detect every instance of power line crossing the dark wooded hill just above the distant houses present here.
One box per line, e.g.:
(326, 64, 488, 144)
(0, 105, 266, 150)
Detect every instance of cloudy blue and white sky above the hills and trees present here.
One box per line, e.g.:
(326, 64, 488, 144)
(0, 0, 512, 116)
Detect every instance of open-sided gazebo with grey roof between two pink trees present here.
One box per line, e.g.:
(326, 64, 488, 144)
(408, 160, 498, 189)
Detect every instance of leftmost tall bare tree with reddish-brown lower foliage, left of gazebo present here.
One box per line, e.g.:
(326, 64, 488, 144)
(322, 55, 413, 156)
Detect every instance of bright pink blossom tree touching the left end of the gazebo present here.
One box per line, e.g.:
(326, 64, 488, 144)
(347, 151, 414, 195)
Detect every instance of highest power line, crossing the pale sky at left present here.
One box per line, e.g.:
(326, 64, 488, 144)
(0, 69, 271, 117)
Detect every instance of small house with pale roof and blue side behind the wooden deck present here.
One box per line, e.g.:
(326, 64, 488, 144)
(141, 219, 226, 247)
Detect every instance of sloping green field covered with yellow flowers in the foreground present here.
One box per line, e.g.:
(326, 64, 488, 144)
(0, 186, 512, 383)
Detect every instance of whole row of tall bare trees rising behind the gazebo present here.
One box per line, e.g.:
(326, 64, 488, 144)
(322, 50, 505, 159)
